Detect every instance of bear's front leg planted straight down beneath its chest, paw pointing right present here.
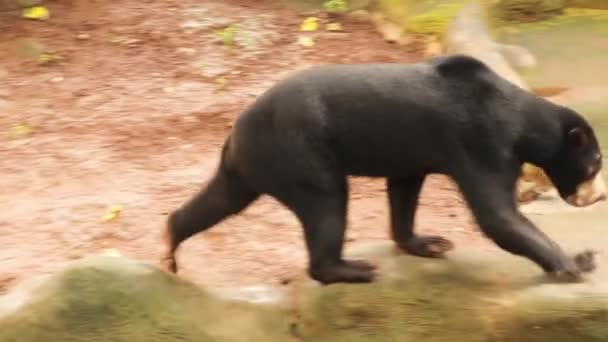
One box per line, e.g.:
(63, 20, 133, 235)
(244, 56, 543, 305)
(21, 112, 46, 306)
(387, 176, 454, 258)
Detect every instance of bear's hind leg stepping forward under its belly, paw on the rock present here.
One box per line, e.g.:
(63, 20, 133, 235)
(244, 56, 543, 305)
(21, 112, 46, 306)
(282, 180, 375, 284)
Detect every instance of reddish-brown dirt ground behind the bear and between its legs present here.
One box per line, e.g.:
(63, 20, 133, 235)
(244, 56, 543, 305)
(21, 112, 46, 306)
(0, 0, 484, 292)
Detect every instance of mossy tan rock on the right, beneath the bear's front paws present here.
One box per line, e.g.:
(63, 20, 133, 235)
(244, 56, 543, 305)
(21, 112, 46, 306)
(297, 223, 608, 342)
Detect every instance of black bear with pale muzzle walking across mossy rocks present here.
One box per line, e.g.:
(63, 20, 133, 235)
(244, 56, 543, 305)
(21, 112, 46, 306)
(163, 55, 605, 284)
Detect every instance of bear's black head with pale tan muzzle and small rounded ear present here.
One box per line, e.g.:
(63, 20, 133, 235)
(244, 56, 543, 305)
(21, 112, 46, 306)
(545, 116, 606, 207)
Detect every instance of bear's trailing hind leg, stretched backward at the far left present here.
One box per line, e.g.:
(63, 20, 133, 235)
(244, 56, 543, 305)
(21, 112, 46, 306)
(162, 165, 259, 273)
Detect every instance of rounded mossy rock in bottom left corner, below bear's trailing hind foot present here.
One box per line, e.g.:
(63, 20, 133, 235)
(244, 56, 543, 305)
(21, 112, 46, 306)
(0, 256, 289, 342)
